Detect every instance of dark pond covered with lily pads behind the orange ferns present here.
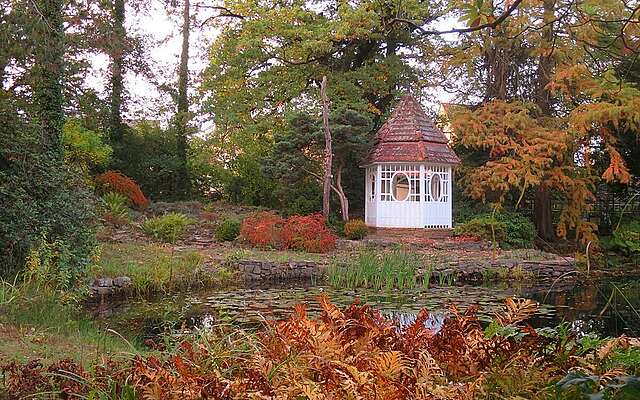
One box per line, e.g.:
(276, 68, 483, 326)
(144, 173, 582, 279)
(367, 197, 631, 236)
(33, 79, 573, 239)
(93, 277, 640, 336)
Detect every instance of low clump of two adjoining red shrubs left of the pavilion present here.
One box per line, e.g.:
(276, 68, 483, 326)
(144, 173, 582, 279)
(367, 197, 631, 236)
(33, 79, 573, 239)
(240, 212, 337, 253)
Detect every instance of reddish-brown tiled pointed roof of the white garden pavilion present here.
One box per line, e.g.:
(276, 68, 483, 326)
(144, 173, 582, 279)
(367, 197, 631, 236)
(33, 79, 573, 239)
(367, 94, 460, 164)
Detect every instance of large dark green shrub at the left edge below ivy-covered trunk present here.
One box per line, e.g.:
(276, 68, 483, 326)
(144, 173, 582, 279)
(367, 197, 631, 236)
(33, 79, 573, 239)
(0, 101, 96, 279)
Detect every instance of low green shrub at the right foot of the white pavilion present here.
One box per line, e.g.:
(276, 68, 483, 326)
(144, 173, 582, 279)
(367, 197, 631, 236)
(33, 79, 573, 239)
(454, 213, 536, 248)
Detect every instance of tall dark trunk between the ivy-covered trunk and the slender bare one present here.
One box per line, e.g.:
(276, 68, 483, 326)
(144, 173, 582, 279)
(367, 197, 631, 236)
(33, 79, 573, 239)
(109, 0, 127, 145)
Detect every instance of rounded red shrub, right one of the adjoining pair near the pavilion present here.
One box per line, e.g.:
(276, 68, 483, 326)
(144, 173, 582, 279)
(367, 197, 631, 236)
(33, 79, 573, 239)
(280, 214, 337, 253)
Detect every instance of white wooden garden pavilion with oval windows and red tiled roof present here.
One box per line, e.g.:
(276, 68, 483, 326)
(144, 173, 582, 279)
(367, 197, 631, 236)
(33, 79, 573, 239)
(363, 95, 460, 229)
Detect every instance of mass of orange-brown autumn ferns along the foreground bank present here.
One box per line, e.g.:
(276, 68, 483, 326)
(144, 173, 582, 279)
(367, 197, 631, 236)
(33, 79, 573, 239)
(2, 296, 631, 400)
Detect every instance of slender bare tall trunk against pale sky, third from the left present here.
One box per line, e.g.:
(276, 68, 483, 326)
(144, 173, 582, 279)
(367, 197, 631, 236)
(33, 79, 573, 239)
(176, 0, 191, 198)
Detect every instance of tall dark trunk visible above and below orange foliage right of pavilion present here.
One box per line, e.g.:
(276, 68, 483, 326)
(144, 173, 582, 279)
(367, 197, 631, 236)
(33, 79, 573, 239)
(533, 0, 557, 242)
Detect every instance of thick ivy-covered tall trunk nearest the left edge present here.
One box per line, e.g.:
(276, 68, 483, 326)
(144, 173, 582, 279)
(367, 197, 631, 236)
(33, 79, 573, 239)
(31, 0, 64, 163)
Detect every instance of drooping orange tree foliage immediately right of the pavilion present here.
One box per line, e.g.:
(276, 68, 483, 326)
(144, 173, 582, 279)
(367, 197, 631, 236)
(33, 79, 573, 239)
(452, 100, 595, 244)
